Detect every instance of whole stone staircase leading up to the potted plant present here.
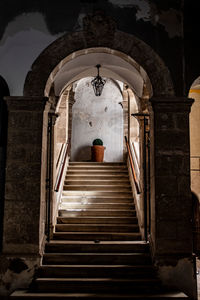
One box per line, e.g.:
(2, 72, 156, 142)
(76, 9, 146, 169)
(11, 163, 187, 300)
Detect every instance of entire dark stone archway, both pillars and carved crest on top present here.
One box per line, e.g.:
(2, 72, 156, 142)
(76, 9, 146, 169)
(3, 11, 195, 297)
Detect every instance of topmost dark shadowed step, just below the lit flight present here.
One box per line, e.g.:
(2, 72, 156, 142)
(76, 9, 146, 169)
(45, 240, 149, 253)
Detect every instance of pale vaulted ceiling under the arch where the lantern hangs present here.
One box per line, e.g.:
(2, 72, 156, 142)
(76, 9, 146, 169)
(53, 52, 151, 97)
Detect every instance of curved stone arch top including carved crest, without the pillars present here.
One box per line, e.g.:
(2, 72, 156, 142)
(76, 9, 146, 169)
(24, 14, 174, 97)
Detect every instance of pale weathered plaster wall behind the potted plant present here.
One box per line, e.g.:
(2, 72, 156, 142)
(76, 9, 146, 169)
(71, 77, 123, 162)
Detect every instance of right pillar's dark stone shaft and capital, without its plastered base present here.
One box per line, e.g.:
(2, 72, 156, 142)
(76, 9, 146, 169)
(151, 98, 192, 256)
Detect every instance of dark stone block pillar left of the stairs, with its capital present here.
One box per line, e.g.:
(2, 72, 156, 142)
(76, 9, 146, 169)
(3, 97, 49, 255)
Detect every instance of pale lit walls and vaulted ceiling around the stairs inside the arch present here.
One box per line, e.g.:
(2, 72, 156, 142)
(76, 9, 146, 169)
(48, 48, 152, 244)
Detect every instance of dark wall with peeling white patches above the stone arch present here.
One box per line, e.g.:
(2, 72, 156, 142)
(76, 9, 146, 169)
(0, 0, 185, 96)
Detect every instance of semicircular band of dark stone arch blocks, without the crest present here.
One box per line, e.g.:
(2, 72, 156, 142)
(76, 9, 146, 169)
(24, 27, 174, 96)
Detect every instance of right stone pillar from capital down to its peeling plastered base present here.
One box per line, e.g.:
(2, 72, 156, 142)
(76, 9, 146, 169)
(150, 97, 196, 298)
